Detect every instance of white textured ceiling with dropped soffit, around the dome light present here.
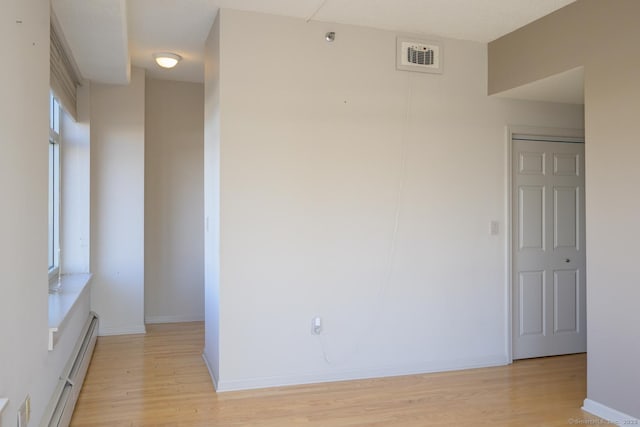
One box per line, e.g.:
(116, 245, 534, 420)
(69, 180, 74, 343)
(52, 0, 574, 89)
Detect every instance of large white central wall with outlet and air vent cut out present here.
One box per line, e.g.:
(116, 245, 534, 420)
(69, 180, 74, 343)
(205, 10, 583, 390)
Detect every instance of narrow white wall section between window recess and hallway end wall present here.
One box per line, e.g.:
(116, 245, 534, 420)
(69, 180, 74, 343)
(91, 68, 145, 335)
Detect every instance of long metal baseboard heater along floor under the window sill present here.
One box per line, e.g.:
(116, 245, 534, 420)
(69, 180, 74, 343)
(41, 312, 98, 427)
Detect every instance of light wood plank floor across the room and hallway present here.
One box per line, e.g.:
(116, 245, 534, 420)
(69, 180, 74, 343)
(71, 323, 597, 427)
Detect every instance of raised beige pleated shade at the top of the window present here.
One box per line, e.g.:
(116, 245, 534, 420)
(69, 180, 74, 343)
(49, 24, 80, 120)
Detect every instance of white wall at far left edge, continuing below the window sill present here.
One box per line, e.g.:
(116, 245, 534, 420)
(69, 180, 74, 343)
(0, 0, 89, 427)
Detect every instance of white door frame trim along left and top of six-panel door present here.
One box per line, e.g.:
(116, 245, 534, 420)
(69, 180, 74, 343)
(504, 125, 586, 364)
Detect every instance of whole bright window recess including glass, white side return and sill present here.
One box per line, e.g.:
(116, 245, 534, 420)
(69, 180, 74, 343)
(41, 90, 91, 351)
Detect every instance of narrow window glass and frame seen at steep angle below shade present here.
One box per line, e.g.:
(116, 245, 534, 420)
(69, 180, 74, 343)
(48, 95, 62, 280)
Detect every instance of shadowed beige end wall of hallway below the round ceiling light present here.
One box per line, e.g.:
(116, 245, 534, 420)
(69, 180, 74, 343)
(144, 79, 204, 323)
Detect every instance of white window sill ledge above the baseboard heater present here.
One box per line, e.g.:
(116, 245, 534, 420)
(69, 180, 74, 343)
(49, 273, 91, 351)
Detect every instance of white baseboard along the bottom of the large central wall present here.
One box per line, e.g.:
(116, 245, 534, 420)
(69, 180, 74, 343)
(215, 355, 509, 392)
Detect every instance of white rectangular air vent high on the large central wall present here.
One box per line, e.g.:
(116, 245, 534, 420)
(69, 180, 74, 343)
(396, 37, 442, 73)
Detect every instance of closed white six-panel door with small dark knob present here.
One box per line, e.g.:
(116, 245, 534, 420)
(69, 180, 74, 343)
(512, 136, 586, 359)
